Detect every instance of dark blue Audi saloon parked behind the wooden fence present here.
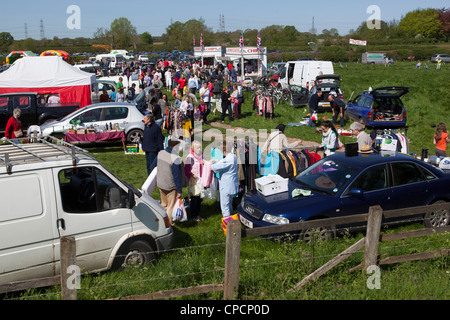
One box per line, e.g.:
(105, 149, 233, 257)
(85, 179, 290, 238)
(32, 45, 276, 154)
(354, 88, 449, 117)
(237, 152, 450, 239)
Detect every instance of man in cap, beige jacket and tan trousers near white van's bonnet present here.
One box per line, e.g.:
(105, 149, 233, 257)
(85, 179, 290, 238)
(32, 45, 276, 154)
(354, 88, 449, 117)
(150, 139, 184, 225)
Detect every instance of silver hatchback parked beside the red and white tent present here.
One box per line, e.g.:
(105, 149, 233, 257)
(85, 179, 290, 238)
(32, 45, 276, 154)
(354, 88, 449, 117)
(41, 102, 144, 143)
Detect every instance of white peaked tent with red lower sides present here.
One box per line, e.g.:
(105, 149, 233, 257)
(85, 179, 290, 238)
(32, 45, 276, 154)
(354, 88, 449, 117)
(0, 56, 95, 107)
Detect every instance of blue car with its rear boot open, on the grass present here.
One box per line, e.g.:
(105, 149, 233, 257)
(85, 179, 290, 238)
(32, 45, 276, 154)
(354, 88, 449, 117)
(345, 87, 409, 129)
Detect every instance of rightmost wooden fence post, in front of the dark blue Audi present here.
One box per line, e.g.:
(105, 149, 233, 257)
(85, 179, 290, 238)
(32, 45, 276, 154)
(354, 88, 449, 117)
(364, 206, 383, 270)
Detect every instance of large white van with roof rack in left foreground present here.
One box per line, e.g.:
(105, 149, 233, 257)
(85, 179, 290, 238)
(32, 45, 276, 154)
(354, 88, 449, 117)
(0, 139, 173, 284)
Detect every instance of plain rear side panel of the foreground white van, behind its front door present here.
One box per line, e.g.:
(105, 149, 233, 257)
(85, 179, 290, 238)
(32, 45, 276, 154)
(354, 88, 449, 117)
(0, 170, 58, 284)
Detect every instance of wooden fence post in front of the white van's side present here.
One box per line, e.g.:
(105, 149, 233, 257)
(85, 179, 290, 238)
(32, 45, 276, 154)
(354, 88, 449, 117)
(60, 237, 77, 300)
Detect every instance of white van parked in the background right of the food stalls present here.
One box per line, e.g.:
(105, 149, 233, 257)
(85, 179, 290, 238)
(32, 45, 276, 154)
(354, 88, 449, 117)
(278, 60, 334, 90)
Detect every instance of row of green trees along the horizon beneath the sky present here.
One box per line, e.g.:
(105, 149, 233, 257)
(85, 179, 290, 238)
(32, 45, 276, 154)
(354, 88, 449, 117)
(0, 8, 450, 52)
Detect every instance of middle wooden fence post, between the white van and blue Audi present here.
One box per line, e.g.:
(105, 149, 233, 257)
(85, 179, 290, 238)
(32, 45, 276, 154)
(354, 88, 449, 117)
(223, 220, 241, 300)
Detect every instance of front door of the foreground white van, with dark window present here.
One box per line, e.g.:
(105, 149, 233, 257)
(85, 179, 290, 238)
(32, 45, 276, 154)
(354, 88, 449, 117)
(54, 166, 131, 271)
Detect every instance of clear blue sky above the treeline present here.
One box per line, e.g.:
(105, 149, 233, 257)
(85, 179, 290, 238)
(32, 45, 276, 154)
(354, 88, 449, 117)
(0, 0, 449, 41)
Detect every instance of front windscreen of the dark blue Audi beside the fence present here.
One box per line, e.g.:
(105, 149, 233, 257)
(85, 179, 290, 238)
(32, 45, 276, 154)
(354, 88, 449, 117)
(295, 158, 360, 196)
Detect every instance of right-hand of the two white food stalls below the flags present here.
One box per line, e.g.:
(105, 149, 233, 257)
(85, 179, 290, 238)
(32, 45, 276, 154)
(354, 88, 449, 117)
(225, 47, 267, 81)
